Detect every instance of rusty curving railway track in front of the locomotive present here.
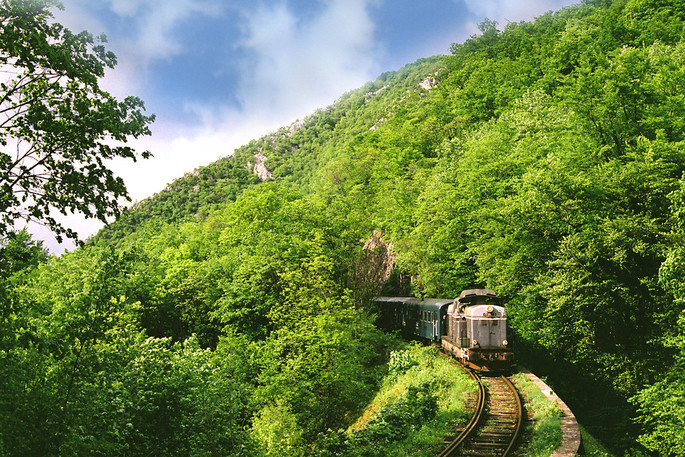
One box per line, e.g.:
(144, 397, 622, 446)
(438, 371, 523, 457)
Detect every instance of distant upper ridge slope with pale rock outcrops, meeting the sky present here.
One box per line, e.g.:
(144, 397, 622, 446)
(95, 57, 446, 244)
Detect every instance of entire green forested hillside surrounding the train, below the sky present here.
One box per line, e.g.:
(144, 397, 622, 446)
(0, 0, 685, 456)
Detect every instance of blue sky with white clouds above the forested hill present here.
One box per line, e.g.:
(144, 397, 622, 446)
(31, 0, 579, 254)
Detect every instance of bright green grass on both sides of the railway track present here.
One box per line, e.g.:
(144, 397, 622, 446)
(314, 344, 568, 457)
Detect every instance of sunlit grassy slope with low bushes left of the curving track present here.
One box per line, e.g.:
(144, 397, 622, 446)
(312, 344, 477, 457)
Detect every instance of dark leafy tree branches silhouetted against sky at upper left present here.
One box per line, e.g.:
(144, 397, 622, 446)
(0, 0, 154, 240)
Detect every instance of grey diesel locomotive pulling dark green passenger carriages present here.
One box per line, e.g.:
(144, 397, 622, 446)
(373, 289, 514, 372)
